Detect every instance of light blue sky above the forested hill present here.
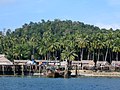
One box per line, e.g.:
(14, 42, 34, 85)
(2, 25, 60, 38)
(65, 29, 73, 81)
(0, 0, 120, 31)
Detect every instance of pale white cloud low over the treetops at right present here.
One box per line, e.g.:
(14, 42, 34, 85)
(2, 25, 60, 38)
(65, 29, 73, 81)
(95, 23, 120, 30)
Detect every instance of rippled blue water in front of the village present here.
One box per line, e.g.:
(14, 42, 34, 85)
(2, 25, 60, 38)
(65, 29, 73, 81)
(0, 77, 120, 90)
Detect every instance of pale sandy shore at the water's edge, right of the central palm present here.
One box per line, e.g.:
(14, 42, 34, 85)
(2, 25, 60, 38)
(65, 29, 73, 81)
(71, 70, 120, 77)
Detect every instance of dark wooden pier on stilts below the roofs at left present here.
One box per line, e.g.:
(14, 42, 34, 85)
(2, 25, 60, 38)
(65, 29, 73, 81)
(0, 65, 45, 76)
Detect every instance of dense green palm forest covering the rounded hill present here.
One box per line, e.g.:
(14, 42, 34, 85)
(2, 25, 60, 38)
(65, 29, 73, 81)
(0, 19, 120, 63)
